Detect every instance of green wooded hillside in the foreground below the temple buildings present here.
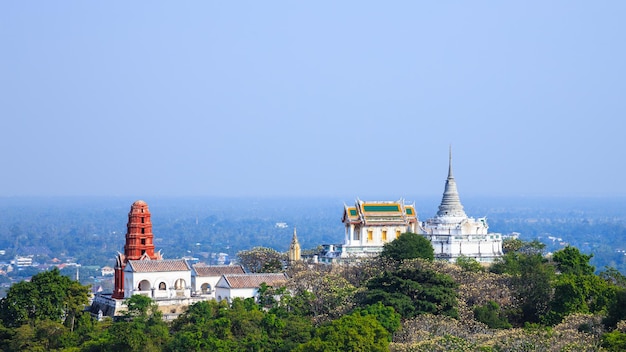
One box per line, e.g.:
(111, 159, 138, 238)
(0, 238, 626, 351)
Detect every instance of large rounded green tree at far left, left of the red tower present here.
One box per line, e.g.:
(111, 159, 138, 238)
(0, 268, 89, 327)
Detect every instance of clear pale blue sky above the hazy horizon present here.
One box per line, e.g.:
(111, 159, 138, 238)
(0, 1, 626, 201)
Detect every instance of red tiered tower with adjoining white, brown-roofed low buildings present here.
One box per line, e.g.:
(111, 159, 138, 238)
(89, 200, 286, 318)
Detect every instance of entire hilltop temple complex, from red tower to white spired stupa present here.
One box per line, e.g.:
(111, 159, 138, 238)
(90, 153, 502, 318)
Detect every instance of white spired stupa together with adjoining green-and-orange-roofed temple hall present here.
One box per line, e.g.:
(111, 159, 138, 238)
(317, 152, 502, 263)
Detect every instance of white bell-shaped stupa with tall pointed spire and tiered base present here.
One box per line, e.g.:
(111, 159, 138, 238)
(421, 152, 502, 263)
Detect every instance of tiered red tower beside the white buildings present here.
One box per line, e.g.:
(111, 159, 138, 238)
(112, 200, 161, 299)
